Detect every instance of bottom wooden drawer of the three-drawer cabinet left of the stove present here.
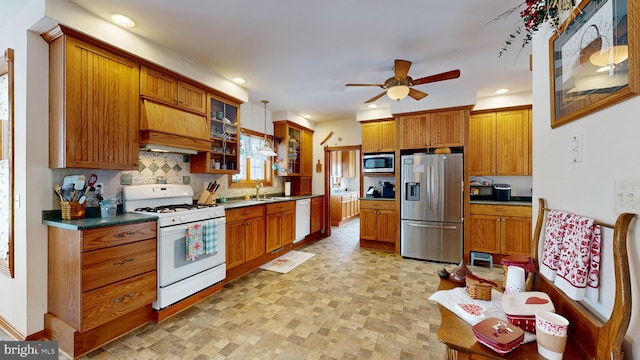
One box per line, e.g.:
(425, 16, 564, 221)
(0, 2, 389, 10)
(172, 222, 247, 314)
(80, 271, 156, 331)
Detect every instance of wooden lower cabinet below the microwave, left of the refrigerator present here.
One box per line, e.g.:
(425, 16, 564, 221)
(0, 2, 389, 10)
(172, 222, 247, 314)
(360, 200, 399, 252)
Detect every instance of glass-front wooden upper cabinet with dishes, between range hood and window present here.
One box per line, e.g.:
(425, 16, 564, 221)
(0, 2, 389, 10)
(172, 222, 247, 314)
(191, 94, 241, 174)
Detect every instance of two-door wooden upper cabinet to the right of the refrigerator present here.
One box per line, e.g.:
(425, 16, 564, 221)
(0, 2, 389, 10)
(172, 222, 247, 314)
(469, 109, 532, 176)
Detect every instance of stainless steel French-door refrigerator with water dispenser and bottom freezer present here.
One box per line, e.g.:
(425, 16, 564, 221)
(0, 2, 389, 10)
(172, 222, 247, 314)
(400, 153, 464, 263)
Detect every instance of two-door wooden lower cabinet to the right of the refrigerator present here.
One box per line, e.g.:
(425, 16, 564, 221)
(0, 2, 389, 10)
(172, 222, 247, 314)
(469, 204, 532, 261)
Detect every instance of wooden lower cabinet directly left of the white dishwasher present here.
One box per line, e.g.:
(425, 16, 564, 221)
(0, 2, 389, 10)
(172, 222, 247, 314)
(266, 201, 296, 252)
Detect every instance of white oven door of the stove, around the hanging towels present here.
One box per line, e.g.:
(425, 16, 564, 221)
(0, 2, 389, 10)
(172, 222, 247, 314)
(158, 217, 226, 288)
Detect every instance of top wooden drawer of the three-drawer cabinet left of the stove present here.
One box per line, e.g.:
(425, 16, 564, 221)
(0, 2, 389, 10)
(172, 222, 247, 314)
(82, 221, 157, 251)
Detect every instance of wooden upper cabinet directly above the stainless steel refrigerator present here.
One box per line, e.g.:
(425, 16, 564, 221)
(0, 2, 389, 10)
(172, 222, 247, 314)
(398, 110, 468, 149)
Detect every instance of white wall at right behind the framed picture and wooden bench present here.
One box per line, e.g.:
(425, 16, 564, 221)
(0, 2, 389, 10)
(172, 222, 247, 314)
(533, 25, 640, 358)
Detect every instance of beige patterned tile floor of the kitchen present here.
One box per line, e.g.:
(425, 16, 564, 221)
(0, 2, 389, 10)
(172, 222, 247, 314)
(0, 220, 502, 360)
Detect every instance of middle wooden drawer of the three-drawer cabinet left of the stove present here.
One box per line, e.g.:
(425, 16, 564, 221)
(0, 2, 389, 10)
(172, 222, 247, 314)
(82, 239, 156, 292)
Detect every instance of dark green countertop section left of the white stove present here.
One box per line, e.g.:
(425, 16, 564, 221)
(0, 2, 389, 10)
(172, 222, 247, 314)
(42, 208, 158, 230)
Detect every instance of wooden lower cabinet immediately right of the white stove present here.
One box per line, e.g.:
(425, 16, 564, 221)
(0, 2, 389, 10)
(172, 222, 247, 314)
(225, 206, 266, 271)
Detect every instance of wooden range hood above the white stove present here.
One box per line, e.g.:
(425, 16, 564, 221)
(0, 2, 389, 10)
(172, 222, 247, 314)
(140, 99, 211, 155)
